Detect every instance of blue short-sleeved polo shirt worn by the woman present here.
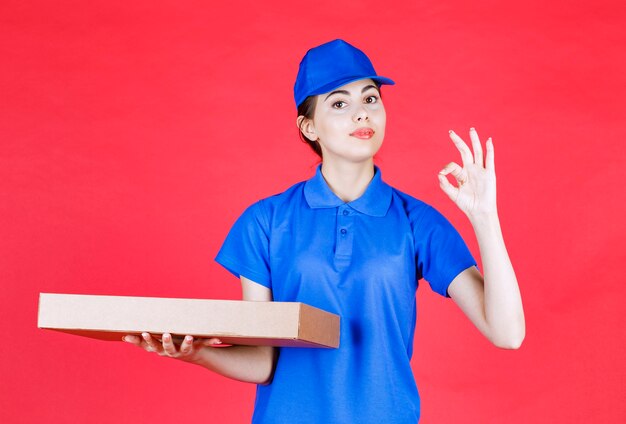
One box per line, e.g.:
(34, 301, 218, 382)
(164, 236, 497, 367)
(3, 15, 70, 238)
(216, 166, 476, 424)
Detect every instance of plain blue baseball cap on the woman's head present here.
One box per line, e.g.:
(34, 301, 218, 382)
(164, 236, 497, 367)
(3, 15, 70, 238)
(293, 40, 395, 106)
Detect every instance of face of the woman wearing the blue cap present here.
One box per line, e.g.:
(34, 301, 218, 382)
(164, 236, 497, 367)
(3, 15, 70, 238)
(307, 79, 387, 162)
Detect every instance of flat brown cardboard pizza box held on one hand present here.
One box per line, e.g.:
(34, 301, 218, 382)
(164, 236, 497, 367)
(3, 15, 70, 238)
(37, 293, 339, 347)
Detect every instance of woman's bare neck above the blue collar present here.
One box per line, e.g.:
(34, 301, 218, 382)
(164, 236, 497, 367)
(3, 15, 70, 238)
(322, 160, 374, 203)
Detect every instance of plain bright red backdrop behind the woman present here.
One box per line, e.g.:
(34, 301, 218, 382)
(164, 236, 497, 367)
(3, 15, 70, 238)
(0, 0, 626, 424)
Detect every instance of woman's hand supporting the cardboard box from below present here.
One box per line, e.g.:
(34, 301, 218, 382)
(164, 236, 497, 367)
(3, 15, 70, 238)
(122, 333, 222, 363)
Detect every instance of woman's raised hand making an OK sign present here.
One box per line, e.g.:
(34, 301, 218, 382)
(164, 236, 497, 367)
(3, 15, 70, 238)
(439, 128, 497, 218)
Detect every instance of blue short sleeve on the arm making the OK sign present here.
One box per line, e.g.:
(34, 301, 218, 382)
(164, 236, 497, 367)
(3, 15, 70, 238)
(414, 206, 476, 297)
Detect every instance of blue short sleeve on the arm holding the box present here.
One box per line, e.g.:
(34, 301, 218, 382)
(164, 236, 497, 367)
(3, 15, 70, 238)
(215, 201, 272, 288)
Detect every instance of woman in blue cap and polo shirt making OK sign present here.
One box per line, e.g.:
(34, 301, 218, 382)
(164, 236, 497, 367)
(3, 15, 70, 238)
(126, 40, 525, 423)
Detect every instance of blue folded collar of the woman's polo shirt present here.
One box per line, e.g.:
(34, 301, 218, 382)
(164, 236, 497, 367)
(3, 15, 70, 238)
(304, 165, 391, 216)
